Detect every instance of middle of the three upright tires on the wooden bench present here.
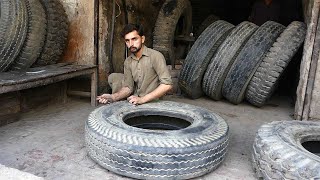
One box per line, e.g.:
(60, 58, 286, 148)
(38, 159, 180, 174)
(10, 0, 47, 71)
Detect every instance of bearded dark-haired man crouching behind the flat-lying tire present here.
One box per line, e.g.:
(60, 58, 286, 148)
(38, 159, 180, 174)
(97, 24, 172, 105)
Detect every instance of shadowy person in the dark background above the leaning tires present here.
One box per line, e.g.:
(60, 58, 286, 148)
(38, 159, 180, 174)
(249, 0, 280, 26)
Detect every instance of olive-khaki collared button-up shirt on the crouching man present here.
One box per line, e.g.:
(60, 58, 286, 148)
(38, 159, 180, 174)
(123, 46, 172, 97)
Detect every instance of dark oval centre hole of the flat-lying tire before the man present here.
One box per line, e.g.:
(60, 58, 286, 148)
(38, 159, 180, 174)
(123, 112, 192, 130)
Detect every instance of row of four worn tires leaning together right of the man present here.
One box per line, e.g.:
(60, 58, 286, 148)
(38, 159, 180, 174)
(179, 20, 306, 107)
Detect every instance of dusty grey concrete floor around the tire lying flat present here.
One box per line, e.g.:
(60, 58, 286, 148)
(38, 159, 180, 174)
(0, 96, 293, 180)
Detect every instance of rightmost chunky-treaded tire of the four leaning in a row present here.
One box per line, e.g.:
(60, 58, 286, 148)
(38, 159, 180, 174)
(246, 21, 306, 107)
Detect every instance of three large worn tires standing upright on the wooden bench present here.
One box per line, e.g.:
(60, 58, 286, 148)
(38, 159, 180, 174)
(0, 0, 68, 72)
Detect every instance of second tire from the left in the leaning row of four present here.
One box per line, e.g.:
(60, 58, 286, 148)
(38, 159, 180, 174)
(202, 21, 258, 100)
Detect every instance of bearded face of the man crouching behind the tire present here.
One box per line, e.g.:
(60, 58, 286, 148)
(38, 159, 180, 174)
(124, 31, 145, 54)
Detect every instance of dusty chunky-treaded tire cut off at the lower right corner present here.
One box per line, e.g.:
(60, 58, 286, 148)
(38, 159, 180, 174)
(252, 121, 320, 180)
